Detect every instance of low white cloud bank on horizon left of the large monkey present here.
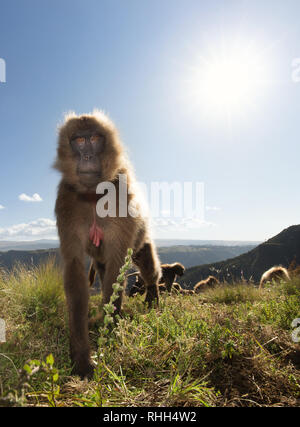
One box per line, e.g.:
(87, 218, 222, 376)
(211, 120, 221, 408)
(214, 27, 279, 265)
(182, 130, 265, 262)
(0, 218, 57, 240)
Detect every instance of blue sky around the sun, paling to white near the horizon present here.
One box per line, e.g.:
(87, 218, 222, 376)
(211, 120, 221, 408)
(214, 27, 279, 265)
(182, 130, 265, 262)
(0, 0, 300, 240)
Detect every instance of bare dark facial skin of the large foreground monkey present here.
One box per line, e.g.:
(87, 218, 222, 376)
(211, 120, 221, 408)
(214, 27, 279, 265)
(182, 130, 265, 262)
(70, 128, 105, 187)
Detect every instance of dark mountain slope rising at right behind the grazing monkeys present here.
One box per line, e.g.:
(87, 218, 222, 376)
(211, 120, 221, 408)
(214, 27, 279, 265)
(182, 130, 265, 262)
(180, 225, 300, 287)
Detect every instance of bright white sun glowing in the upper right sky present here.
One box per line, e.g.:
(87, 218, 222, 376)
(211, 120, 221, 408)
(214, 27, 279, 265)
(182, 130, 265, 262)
(184, 38, 268, 117)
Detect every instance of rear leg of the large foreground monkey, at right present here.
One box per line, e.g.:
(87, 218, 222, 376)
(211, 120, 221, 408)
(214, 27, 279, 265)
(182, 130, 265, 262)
(133, 243, 161, 307)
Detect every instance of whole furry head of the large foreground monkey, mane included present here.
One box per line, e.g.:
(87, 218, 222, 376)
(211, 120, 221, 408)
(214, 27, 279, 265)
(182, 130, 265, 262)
(54, 111, 123, 193)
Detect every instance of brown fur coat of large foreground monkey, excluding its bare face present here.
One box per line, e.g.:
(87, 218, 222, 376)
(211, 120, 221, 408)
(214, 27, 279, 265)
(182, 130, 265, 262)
(54, 111, 161, 378)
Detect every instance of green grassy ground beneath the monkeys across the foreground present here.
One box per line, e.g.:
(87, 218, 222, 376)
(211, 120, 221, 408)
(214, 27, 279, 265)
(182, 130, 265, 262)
(0, 262, 300, 407)
